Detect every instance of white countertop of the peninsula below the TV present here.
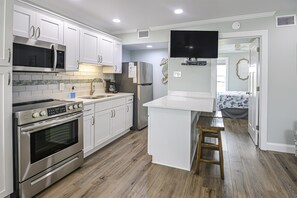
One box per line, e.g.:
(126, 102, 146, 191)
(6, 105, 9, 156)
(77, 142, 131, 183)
(143, 96, 214, 112)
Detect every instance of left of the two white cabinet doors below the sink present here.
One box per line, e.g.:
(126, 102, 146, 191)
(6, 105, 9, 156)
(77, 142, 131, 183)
(94, 110, 112, 147)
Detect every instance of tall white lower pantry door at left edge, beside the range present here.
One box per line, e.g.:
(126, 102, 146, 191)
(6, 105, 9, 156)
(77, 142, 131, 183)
(0, 66, 14, 197)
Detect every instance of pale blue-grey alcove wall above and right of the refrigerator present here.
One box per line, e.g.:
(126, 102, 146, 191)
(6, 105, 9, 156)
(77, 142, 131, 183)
(126, 49, 168, 99)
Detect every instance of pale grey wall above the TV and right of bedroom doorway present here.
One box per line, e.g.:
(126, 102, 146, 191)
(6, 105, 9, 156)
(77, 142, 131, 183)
(117, 10, 297, 148)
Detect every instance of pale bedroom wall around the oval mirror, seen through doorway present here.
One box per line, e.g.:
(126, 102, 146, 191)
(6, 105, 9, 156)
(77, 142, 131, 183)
(219, 53, 250, 91)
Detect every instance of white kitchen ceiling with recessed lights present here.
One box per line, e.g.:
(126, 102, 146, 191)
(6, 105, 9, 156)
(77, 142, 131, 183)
(23, 0, 297, 33)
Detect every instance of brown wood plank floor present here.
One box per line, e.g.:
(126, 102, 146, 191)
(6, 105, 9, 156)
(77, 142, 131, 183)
(37, 119, 297, 198)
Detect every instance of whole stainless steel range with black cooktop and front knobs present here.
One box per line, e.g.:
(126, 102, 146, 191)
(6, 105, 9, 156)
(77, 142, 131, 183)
(13, 99, 83, 197)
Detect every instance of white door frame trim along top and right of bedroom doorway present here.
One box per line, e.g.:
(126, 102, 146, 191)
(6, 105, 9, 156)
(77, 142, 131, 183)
(219, 30, 268, 150)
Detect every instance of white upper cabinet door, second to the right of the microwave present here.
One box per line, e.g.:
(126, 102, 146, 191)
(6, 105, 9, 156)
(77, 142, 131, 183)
(80, 29, 99, 64)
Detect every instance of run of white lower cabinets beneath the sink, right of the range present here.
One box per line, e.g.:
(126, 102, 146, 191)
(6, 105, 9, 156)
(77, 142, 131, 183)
(83, 96, 133, 157)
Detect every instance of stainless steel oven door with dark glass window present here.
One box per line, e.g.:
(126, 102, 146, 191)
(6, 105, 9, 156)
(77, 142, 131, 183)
(18, 112, 83, 182)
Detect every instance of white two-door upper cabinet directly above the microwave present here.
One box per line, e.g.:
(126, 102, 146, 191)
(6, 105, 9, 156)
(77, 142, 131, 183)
(13, 5, 63, 44)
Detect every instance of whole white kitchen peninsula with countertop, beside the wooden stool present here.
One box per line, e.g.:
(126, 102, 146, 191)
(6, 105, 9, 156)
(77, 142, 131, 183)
(144, 95, 214, 171)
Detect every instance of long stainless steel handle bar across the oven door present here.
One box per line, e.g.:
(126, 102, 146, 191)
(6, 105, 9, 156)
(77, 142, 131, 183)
(21, 113, 83, 133)
